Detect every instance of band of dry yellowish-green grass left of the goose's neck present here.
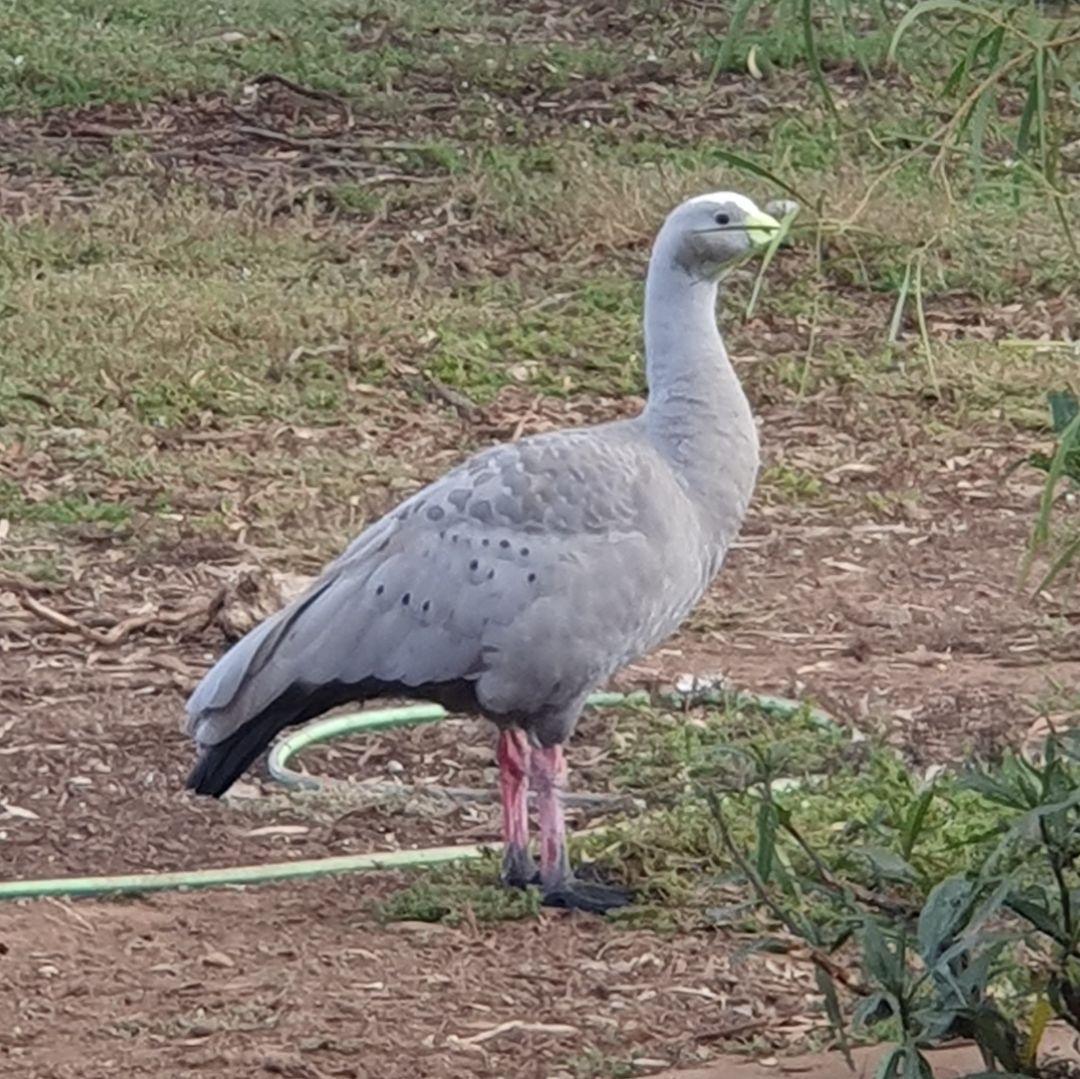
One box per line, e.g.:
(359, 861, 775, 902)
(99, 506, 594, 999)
(0, 196, 640, 427)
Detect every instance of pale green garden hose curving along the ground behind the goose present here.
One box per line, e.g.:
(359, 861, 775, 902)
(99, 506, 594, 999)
(0, 689, 840, 900)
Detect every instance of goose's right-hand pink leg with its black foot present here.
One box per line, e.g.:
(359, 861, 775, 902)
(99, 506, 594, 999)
(530, 745, 633, 914)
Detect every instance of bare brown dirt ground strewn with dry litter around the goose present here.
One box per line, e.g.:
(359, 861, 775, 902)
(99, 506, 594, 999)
(0, 78, 1080, 1079)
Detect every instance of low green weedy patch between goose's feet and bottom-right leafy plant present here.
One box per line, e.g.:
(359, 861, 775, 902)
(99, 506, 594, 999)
(581, 709, 1000, 909)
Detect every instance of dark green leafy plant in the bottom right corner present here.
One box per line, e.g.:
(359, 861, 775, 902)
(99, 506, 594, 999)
(711, 734, 1080, 1079)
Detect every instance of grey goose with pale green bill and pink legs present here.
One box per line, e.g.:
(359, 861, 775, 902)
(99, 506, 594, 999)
(187, 192, 779, 912)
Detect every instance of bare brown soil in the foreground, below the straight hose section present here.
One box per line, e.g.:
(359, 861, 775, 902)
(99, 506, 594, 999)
(0, 878, 808, 1079)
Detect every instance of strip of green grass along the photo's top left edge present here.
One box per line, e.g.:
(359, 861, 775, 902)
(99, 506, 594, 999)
(0, 0, 725, 111)
